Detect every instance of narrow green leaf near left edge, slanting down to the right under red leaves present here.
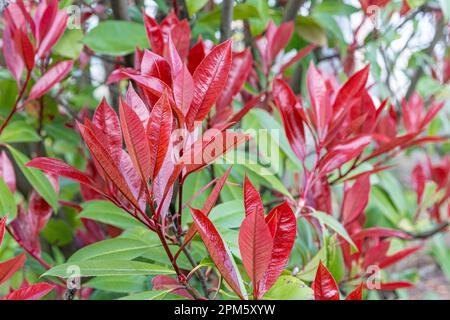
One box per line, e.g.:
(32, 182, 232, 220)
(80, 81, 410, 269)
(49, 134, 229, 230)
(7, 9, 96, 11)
(8, 145, 58, 212)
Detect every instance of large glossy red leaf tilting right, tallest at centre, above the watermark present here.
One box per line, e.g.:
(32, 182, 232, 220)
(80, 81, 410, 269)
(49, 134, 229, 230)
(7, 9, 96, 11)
(186, 40, 231, 131)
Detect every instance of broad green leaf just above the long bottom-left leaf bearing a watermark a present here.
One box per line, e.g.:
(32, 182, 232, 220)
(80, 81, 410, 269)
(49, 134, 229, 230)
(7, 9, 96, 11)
(68, 238, 153, 263)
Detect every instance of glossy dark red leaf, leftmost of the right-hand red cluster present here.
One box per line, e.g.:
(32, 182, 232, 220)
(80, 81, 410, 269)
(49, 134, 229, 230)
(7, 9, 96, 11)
(273, 79, 305, 160)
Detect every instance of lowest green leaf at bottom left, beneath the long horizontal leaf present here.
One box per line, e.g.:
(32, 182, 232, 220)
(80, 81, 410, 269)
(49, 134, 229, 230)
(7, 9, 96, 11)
(83, 276, 149, 293)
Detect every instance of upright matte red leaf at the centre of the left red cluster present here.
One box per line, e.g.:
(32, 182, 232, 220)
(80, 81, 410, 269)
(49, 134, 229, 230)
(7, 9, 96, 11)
(119, 98, 151, 184)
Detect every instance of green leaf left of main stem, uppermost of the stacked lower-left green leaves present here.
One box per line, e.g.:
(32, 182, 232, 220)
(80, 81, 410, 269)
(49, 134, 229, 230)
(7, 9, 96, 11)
(79, 200, 142, 229)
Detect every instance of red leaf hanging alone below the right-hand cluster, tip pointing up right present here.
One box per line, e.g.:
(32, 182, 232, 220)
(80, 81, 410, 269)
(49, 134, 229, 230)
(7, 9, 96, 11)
(341, 175, 370, 226)
